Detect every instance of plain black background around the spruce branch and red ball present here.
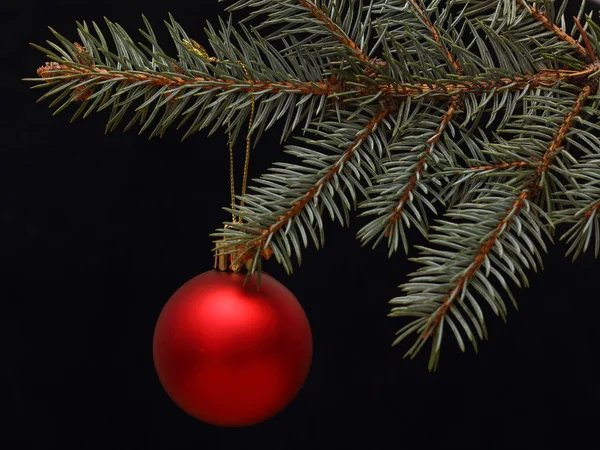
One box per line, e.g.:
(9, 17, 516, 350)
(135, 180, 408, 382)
(0, 0, 600, 450)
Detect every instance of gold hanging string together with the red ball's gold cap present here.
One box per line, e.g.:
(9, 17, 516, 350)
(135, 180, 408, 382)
(183, 39, 255, 272)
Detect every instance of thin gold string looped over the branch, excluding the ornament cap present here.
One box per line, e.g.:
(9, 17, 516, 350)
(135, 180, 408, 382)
(183, 39, 255, 224)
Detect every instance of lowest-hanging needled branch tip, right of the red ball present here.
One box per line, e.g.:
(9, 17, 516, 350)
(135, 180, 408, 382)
(389, 183, 545, 370)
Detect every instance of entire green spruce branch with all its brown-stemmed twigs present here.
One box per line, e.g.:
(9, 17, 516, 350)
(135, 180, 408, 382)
(29, 0, 600, 370)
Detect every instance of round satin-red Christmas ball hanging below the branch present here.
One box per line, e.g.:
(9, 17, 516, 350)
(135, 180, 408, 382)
(153, 270, 312, 427)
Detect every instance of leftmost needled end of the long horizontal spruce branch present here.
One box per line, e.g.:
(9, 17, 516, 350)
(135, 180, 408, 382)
(26, 17, 346, 144)
